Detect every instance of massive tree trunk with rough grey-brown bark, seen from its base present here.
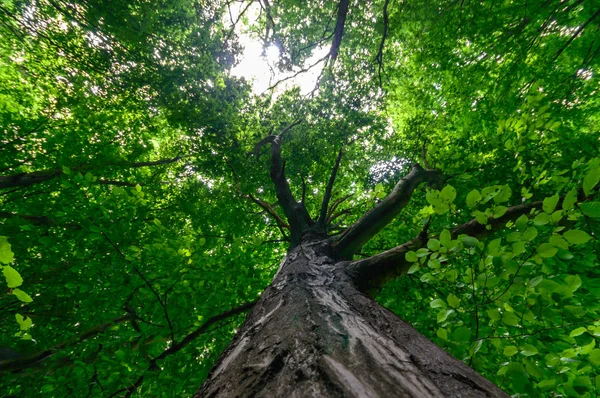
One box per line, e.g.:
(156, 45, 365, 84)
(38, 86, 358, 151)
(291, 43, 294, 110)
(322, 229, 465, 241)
(195, 239, 507, 398)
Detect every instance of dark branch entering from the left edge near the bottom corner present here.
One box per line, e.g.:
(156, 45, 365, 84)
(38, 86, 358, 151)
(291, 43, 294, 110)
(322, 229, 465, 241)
(0, 312, 135, 372)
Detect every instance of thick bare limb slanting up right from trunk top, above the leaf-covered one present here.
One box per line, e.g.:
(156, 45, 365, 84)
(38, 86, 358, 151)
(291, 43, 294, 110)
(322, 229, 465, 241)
(334, 164, 440, 259)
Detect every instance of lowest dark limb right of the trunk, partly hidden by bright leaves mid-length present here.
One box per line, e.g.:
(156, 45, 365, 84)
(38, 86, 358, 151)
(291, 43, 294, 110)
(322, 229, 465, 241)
(347, 200, 562, 292)
